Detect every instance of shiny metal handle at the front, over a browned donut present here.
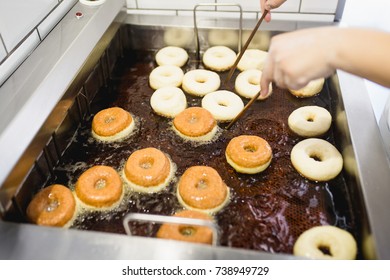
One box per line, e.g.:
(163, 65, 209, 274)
(123, 213, 218, 246)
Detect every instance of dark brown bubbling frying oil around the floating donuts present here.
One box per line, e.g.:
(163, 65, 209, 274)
(51, 51, 354, 253)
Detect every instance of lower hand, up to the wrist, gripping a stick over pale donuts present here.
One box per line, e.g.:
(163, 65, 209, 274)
(260, 27, 337, 96)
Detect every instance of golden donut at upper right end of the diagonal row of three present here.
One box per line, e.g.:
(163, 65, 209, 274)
(123, 148, 175, 193)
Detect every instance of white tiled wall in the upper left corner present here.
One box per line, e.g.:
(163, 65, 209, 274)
(0, 0, 78, 87)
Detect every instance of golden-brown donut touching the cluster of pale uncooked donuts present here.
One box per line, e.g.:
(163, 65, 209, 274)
(173, 107, 218, 141)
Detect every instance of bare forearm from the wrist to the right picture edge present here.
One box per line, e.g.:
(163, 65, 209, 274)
(331, 28, 390, 87)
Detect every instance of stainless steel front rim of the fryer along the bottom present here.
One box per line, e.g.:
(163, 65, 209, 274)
(0, 221, 293, 260)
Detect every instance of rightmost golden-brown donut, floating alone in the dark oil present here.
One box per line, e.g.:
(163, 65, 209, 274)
(225, 135, 272, 174)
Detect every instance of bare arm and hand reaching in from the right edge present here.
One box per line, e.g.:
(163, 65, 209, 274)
(260, 27, 390, 96)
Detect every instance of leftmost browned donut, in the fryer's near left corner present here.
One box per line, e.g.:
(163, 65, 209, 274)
(26, 184, 76, 227)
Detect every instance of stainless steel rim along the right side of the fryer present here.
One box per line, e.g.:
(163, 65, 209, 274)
(337, 71, 390, 259)
